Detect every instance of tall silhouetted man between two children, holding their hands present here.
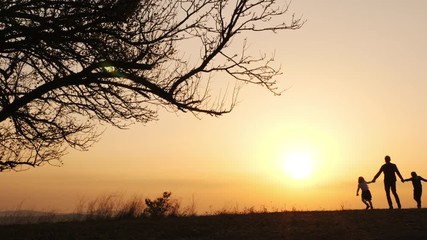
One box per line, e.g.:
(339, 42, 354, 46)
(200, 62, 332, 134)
(372, 156, 404, 209)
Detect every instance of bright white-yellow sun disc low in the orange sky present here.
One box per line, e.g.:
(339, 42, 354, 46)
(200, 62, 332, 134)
(283, 151, 314, 180)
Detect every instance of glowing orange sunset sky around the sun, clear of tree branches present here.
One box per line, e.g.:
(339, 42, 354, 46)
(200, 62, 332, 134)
(0, 0, 427, 213)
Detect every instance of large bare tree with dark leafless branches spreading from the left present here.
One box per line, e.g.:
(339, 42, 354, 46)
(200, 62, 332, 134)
(0, 0, 304, 171)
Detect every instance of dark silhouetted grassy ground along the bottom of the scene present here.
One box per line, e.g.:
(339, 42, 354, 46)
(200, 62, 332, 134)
(0, 209, 427, 240)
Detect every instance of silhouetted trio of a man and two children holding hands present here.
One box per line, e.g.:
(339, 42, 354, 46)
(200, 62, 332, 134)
(356, 155, 427, 209)
